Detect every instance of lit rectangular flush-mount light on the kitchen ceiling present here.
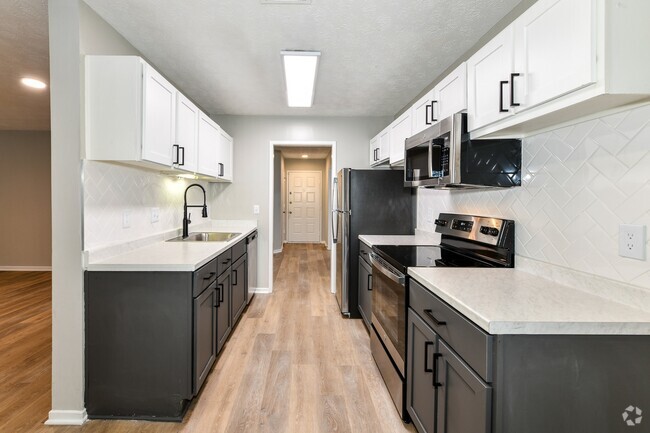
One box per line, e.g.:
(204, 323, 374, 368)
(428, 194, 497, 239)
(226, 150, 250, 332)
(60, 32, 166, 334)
(280, 51, 320, 107)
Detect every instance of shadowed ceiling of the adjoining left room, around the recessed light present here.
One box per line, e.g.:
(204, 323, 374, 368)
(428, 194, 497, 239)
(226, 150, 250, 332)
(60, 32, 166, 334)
(0, 0, 50, 130)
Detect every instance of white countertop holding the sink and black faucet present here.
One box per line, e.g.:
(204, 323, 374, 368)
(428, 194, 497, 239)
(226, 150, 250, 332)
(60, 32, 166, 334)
(86, 222, 257, 272)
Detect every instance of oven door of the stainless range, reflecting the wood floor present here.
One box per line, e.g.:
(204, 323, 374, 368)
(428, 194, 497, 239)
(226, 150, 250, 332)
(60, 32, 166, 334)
(370, 253, 406, 377)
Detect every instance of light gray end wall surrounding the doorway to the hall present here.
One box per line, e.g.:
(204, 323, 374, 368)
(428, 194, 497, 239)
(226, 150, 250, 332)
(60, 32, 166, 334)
(212, 116, 390, 288)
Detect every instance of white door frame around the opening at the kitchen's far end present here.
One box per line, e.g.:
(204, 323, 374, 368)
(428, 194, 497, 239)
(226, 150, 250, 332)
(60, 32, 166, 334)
(268, 140, 337, 293)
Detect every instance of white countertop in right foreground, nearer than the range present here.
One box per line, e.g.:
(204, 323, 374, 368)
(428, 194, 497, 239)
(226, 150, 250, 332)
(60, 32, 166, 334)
(408, 268, 650, 335)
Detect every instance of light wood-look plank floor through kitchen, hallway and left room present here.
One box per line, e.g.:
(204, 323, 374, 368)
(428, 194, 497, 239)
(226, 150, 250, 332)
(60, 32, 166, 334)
(6, 244, 415, 433)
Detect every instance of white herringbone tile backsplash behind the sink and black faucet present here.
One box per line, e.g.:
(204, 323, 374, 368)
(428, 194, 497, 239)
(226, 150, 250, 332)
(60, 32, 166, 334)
(84, 161, 213, 250)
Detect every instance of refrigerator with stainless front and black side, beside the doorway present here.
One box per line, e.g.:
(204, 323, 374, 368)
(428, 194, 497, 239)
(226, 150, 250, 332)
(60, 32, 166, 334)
(332, 168, 416, 318)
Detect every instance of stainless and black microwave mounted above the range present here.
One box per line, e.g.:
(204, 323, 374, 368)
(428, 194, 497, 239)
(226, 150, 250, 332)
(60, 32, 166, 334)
(404, 113, 521, 189)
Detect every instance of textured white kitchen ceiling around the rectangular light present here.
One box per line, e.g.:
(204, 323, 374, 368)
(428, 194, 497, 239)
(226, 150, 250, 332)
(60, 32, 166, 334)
(83, 0, 519, 116)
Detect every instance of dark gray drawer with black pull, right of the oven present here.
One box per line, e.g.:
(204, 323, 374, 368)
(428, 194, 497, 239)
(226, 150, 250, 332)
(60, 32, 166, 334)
(409, 279, 494, 382)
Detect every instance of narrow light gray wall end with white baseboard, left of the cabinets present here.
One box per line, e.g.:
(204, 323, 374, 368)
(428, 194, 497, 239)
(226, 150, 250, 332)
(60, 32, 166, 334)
(46, 0, 87, 425)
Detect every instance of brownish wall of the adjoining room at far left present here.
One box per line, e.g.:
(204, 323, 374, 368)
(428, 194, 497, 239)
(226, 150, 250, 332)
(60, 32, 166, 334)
(0, 131, 52, 269)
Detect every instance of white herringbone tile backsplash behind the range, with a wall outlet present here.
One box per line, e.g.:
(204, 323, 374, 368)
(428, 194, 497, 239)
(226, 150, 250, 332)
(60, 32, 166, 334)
(418, 105, 650, 288)
